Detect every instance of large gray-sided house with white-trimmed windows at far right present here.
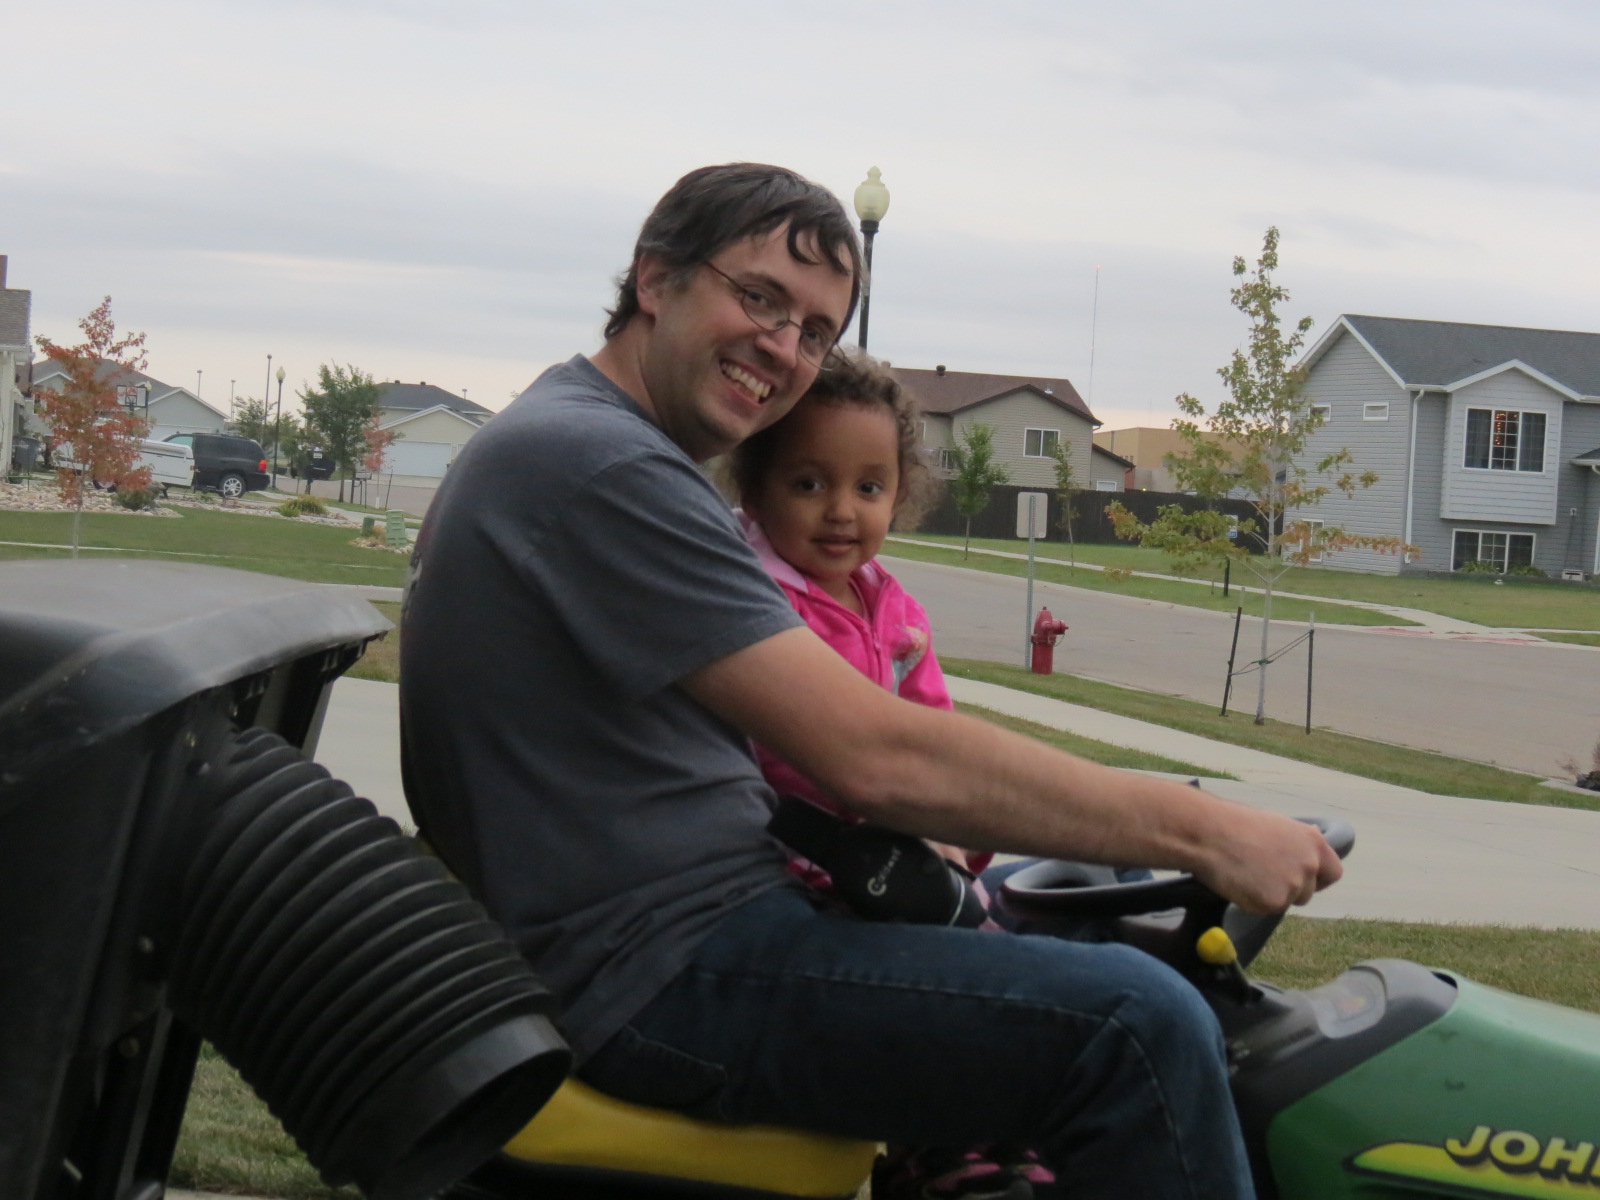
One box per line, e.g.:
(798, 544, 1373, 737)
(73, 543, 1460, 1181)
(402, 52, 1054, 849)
(1304, 315, 1600, 574)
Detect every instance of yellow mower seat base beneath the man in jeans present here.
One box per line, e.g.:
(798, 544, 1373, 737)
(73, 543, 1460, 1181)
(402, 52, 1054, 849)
(504, 1078, 878, 1197)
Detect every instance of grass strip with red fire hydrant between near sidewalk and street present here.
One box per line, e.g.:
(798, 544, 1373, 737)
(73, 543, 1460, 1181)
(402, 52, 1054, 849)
(939, 658, 1600, 810)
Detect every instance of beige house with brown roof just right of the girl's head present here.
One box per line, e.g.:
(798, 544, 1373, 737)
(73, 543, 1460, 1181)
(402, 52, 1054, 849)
(890, 366, 1114, 490)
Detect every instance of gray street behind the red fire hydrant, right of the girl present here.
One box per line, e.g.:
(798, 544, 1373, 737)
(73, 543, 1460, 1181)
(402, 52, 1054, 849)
(883, 557, 1600, 776)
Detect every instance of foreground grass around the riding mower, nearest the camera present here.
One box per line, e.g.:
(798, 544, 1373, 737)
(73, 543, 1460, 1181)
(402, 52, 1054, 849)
(171, 915, 1600, 1200)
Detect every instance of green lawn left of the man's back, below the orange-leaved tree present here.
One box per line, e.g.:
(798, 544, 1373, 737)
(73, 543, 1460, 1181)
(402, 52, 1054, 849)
(0, 507, 406, 587)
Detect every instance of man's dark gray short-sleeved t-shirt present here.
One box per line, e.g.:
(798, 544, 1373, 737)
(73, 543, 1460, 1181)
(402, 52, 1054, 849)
(400, 355, 800, 1056)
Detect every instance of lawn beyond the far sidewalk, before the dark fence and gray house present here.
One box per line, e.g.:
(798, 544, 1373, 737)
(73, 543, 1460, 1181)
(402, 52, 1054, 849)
(885, 533, 1600, 630)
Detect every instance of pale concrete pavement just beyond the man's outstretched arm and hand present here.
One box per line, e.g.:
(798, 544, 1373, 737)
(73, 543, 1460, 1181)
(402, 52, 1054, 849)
(947, 678, 1600, 930)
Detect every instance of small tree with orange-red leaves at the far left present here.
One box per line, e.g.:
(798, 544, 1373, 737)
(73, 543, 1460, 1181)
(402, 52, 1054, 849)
(34, 296, 150, 555)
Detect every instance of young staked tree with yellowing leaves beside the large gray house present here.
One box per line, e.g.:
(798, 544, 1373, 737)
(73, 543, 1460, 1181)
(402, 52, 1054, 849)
(1109, 226, 1410, 725)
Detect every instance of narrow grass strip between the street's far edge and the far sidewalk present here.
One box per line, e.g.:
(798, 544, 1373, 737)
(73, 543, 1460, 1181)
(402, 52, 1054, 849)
(883, 539, 1414, 626)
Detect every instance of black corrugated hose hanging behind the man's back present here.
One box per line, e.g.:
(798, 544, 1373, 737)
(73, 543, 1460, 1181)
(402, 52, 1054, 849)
(160, 730, 570, 1200)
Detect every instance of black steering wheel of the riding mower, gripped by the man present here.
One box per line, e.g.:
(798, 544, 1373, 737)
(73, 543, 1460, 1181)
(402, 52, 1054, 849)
(1000, 816, 1355, 968)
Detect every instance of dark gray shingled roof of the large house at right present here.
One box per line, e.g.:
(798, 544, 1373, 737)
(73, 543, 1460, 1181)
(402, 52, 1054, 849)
(1306, 314, 1600, 397)
